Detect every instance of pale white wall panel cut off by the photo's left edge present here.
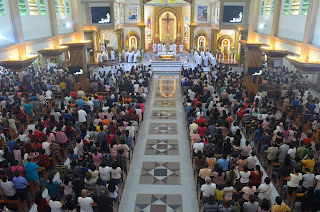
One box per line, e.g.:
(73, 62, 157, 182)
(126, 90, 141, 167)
(0, 0, 15, 46)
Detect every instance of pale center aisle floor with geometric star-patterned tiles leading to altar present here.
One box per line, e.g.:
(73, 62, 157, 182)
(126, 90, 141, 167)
(119, 75, 199, 212)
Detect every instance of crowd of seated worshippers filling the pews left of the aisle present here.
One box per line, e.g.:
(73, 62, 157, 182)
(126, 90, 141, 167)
(0, 63, 152, 212)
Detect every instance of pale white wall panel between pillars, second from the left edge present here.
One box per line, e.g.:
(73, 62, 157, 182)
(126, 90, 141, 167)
(21, 0, 52, 40)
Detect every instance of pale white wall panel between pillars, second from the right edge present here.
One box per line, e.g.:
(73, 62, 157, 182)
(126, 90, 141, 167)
(278, 0, 307, 41)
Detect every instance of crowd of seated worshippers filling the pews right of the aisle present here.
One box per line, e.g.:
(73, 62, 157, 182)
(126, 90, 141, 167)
(181, 64, 320, 212)
